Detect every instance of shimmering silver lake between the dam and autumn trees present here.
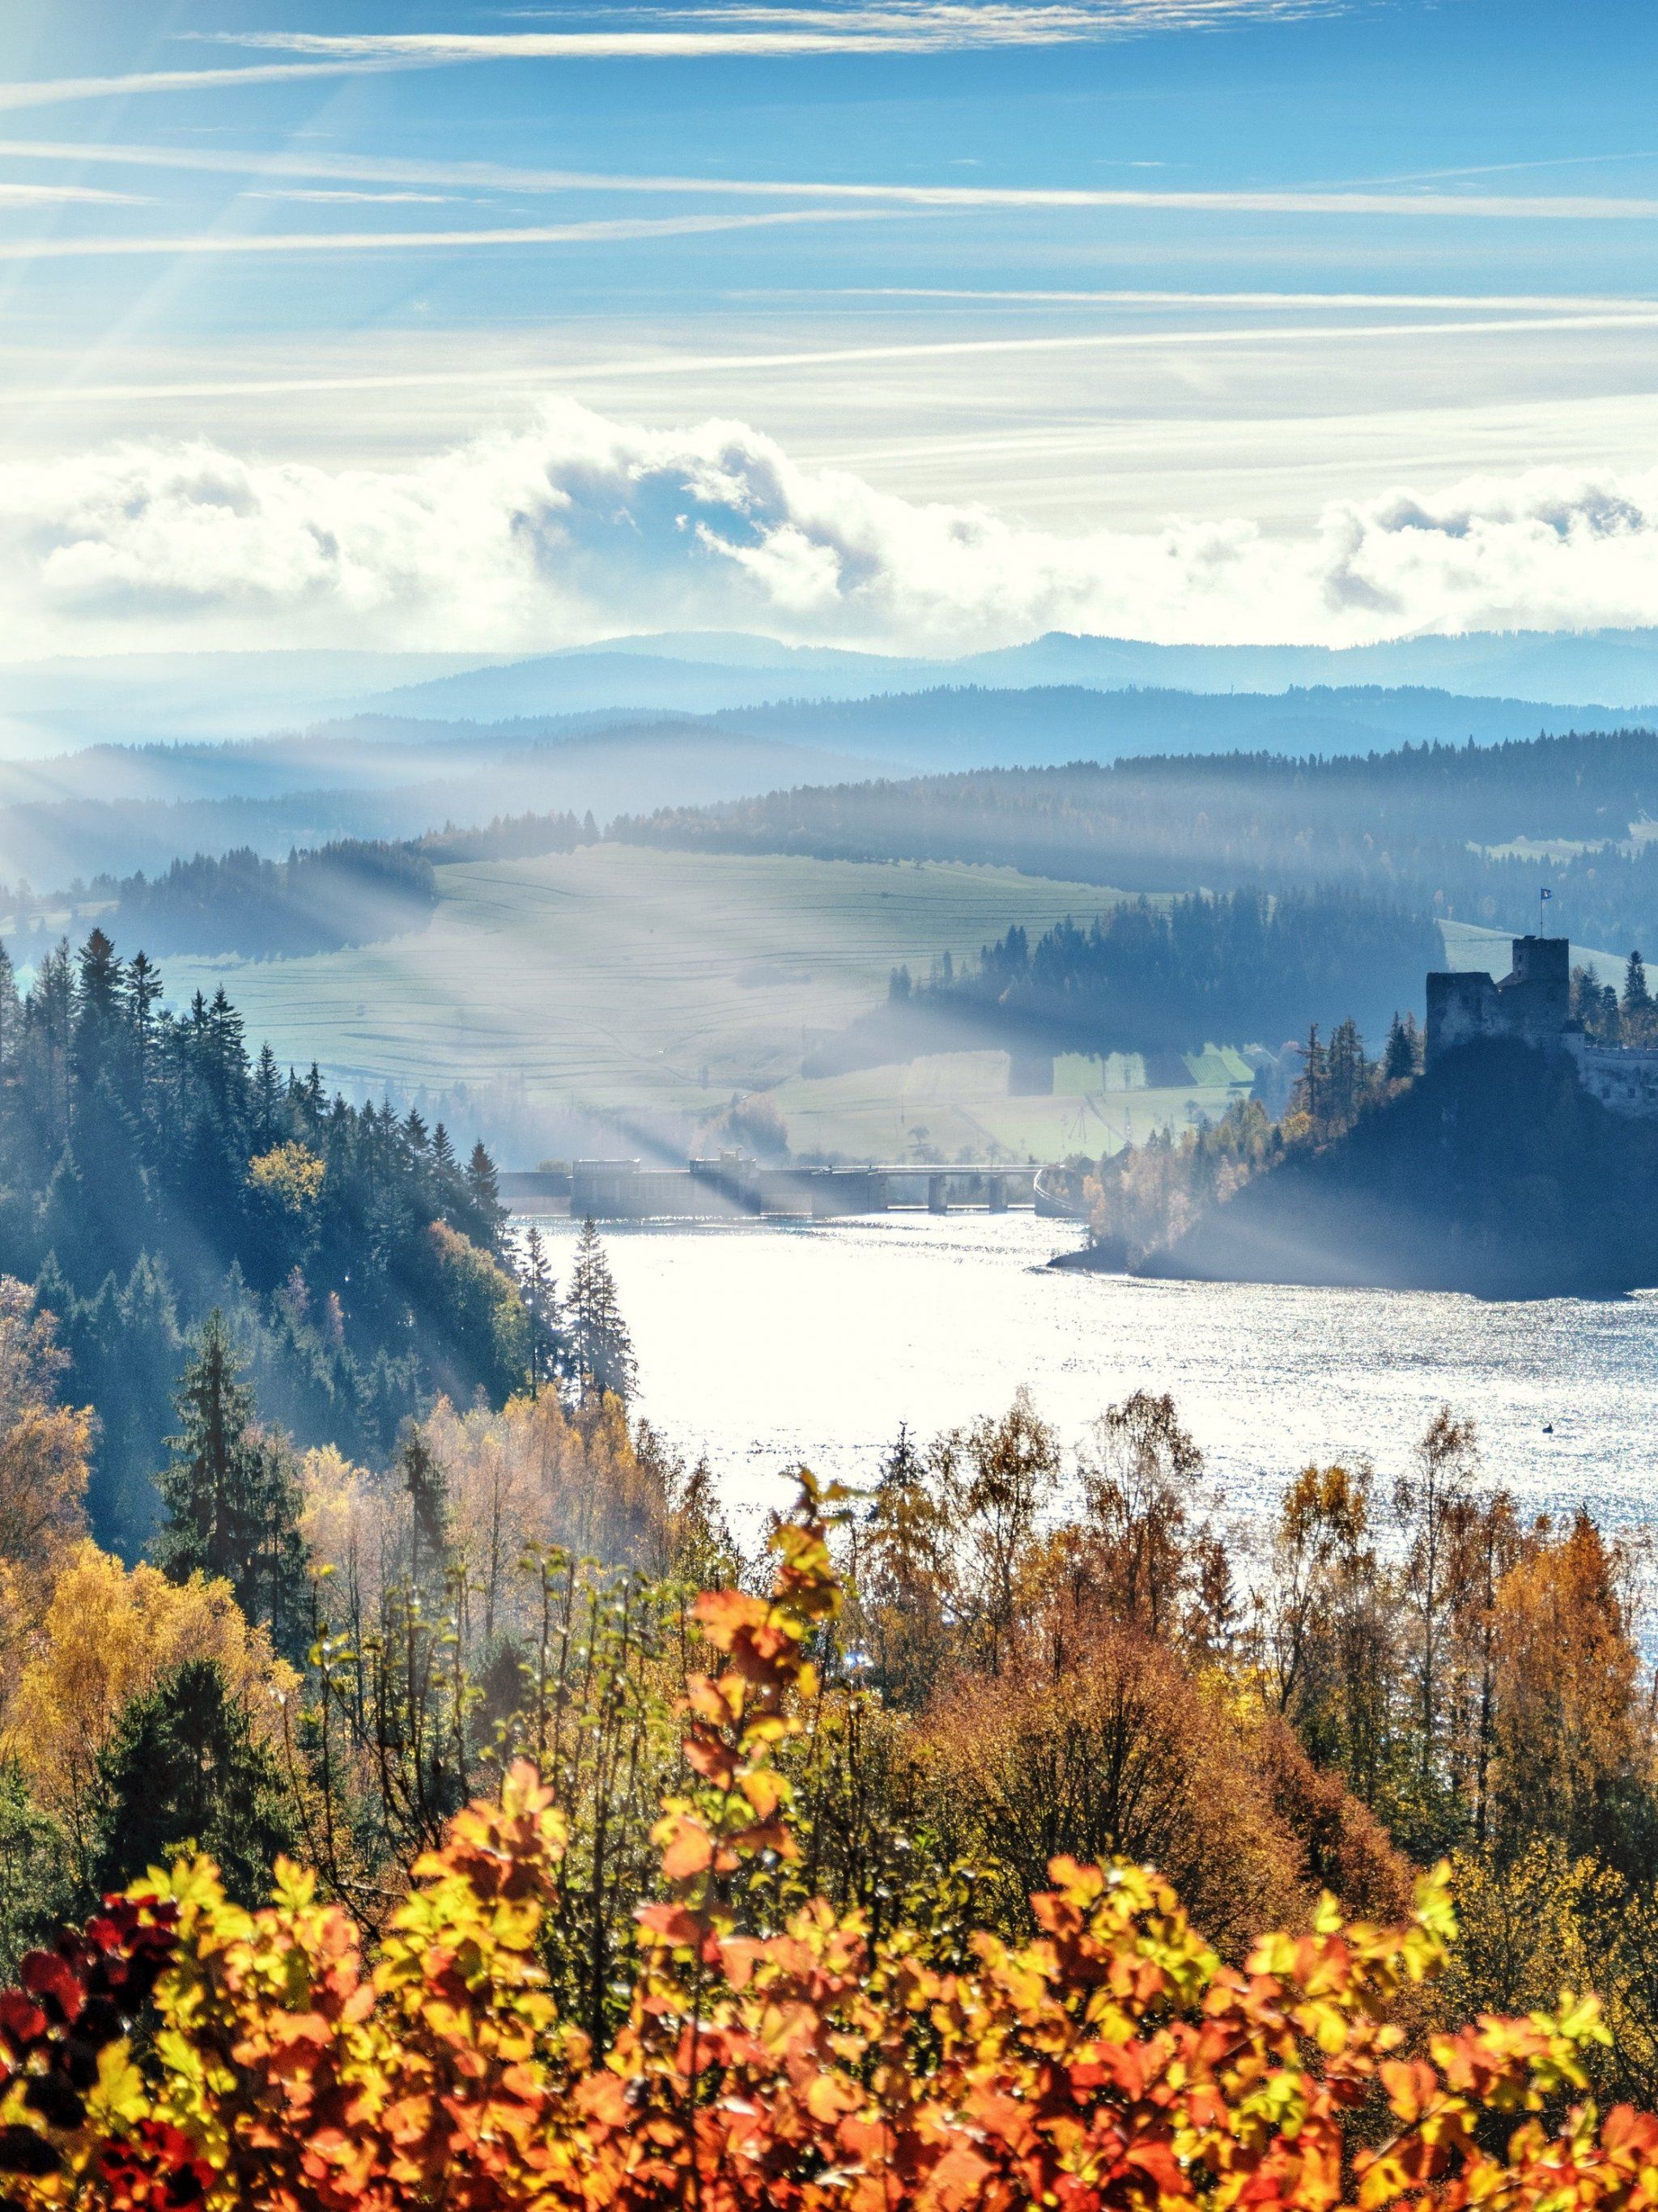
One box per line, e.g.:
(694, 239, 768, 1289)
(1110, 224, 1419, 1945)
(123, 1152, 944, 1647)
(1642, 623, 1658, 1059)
(525, 1214, 1658, 1526)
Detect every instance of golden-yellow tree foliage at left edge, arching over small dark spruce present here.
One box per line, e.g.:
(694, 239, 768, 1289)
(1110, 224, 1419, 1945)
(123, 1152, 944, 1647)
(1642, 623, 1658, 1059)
(4, 1542, 299, 1844)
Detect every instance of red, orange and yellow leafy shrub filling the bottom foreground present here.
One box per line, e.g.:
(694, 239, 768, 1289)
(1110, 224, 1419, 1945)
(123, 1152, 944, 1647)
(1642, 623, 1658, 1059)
(0, 1493, 1658, 2212)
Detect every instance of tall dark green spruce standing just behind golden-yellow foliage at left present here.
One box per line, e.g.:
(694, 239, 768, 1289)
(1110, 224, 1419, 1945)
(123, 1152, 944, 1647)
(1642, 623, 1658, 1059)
(155, 1308, 308, 1653)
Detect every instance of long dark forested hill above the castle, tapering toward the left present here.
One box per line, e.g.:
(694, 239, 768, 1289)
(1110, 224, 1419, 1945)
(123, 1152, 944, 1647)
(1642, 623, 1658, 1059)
(610, 730, 1658, 946)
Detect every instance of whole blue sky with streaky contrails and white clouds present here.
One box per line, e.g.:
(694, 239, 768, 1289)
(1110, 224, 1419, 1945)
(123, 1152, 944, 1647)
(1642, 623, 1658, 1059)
(0, 0, 1658, 657)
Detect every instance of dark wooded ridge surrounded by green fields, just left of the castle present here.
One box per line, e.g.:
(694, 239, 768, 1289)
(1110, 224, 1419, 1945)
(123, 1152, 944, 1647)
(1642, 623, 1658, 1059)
(807, 891, 1441, 1075)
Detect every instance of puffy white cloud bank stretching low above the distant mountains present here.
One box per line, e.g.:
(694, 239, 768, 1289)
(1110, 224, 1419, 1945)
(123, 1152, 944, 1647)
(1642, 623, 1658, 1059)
(0, 402, 1658, 657)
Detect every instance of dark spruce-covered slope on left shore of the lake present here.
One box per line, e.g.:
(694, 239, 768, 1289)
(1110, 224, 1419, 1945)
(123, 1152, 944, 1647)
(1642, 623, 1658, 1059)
(0, 931, 526, 1544)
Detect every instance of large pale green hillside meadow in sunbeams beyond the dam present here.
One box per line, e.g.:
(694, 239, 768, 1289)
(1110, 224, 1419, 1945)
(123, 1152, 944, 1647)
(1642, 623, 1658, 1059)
(164, 845, 1158, 1142)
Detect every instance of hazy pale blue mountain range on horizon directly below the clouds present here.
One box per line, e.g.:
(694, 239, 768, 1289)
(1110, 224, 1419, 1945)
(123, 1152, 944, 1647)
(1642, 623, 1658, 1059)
(0, 628, 1658, 759)
